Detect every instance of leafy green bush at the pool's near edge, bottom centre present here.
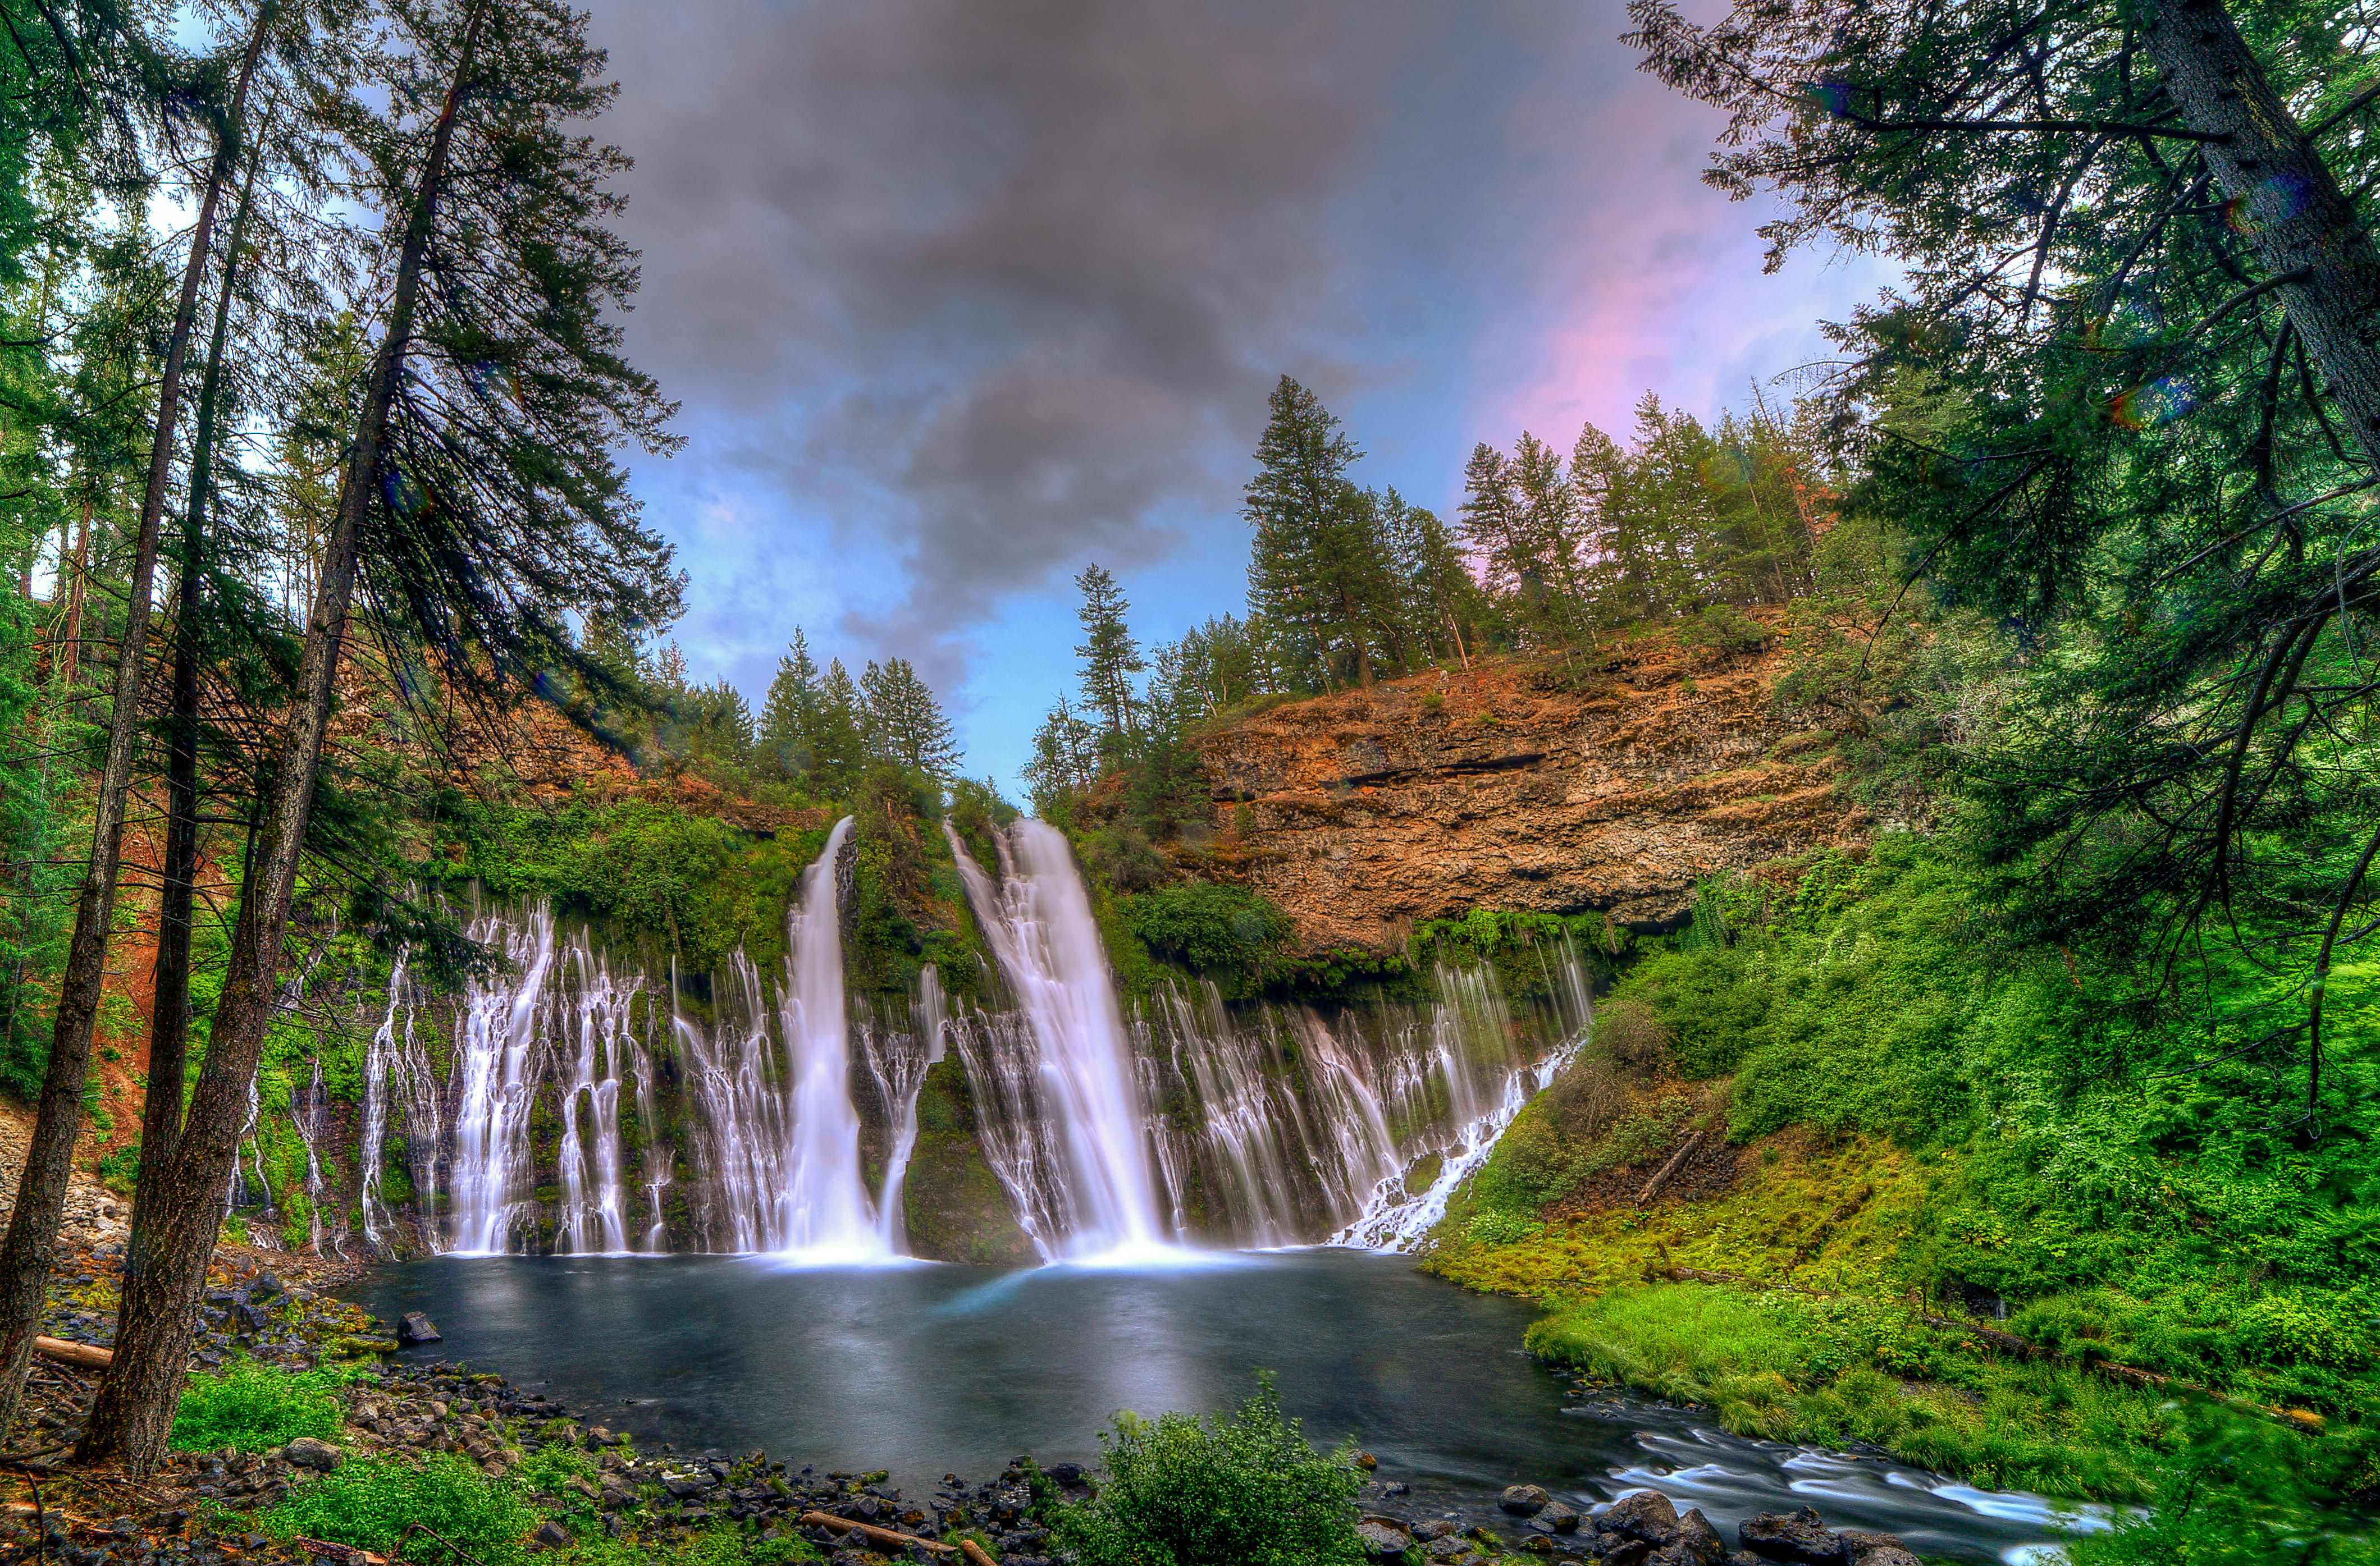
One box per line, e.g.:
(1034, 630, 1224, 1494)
(1054, 1376, 1364, 1566)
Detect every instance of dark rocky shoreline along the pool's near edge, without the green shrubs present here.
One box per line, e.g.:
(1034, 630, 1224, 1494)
(0, 1247, 1951, 1566)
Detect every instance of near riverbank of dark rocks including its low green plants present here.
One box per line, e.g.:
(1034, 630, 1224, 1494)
(0, 1254, 2046, 1566)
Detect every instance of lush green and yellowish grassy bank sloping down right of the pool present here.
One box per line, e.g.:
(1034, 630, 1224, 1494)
(1431, 838, 2380, 1532)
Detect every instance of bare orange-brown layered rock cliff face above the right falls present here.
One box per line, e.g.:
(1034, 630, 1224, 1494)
(1183, 638, 1866, 950)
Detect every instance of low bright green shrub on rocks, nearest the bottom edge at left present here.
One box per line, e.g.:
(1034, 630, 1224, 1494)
(264, 1451, 538, 1566)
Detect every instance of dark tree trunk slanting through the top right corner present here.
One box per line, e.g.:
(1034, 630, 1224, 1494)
(2147, 0, 2380, 462)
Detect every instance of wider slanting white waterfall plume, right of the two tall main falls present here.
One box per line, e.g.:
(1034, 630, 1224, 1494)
(943, 819, 1171, 1257)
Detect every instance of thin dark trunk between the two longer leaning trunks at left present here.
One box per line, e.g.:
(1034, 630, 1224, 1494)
(124, 146, 262, 1333)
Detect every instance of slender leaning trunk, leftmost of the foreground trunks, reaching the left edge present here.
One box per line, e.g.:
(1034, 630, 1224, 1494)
(0, 0, 276, 1435)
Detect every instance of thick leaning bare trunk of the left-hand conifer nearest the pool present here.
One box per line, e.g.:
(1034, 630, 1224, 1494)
(76, 0, 486, 1478)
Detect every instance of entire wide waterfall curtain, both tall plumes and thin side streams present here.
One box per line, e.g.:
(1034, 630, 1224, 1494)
(347, 819, 1592, 1264)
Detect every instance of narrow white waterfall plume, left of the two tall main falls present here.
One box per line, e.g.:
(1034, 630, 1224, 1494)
(769, 816, 890, 1261)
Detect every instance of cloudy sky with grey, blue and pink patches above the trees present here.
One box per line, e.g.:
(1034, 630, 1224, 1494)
(593, 0, 1883, 797)
